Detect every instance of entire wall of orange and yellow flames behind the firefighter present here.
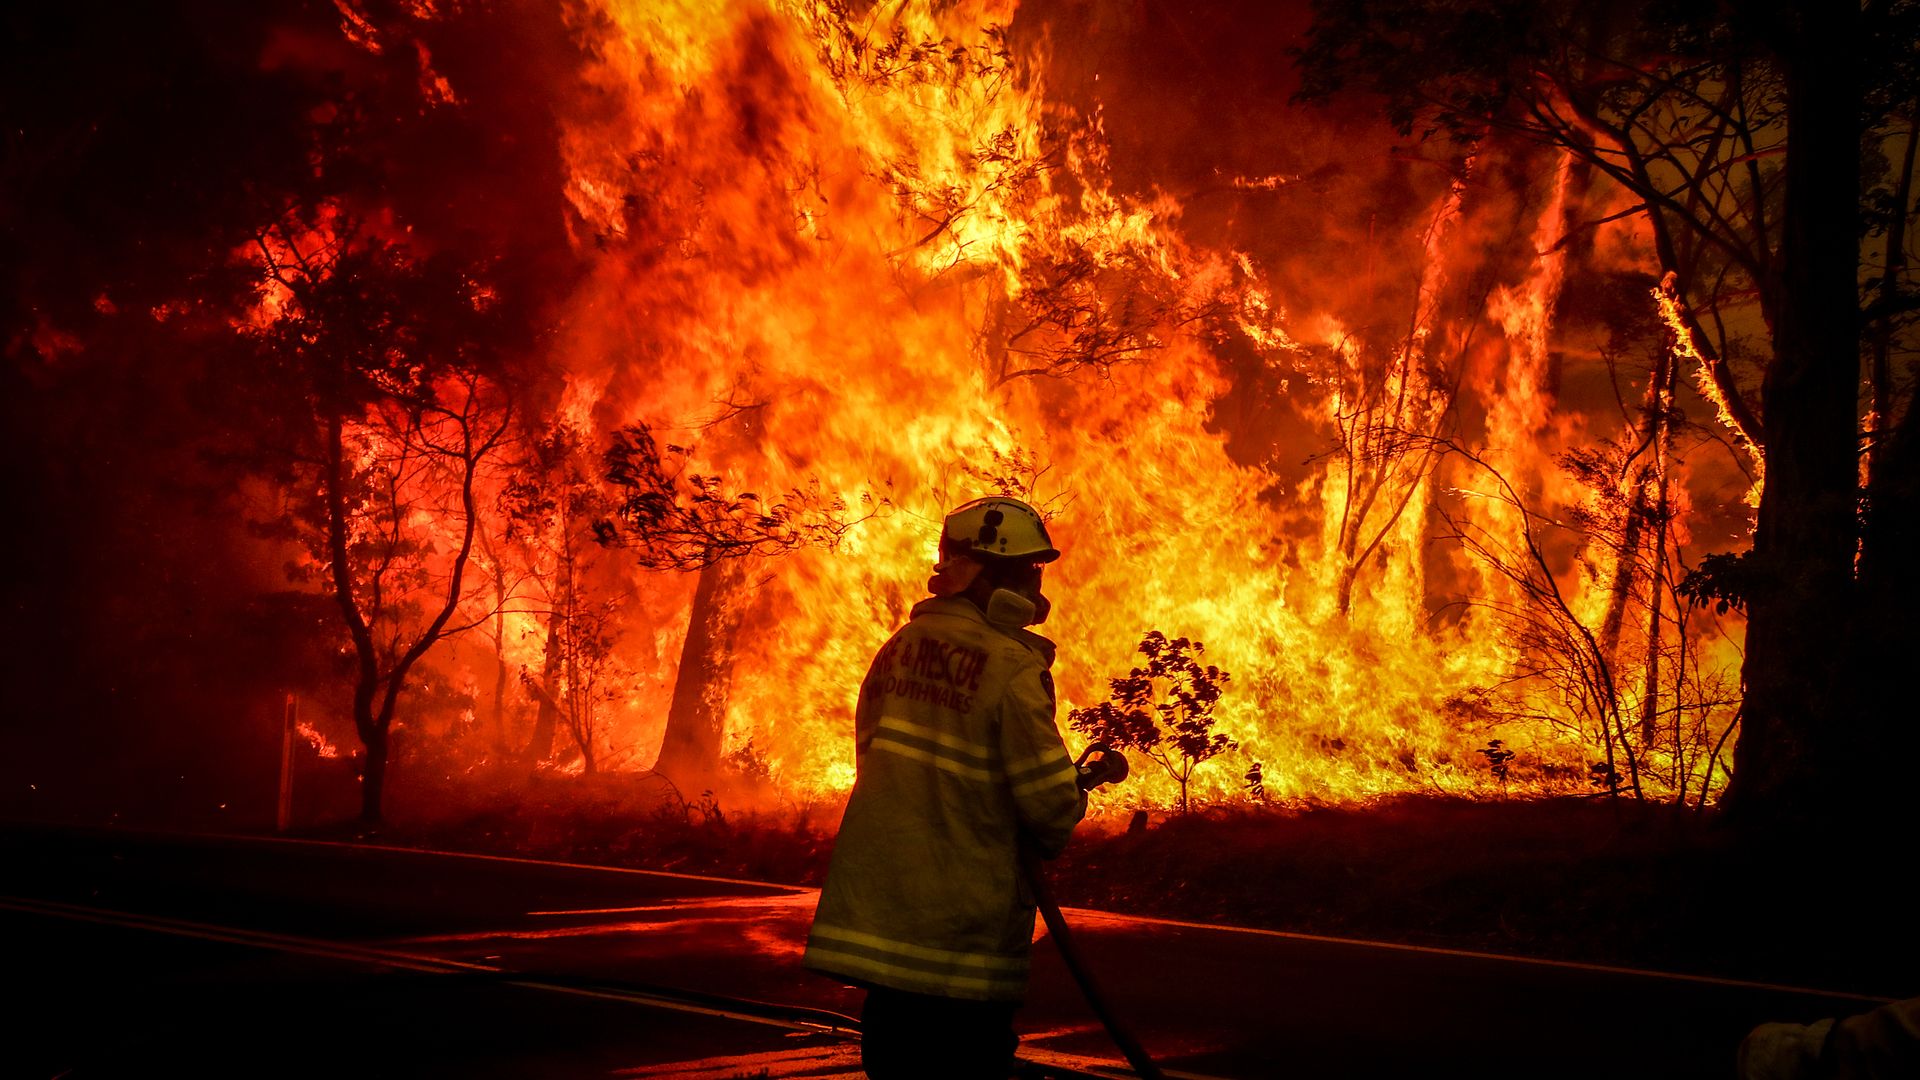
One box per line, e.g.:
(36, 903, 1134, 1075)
(261, 0, 1745, 803)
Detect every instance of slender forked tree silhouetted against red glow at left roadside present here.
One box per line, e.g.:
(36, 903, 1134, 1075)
(255, 215, 513, 824)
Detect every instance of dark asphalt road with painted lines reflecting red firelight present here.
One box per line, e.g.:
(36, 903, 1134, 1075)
(0, 824, 1880, 1080)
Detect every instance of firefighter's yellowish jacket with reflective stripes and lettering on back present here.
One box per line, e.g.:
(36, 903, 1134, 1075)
(804, 590, 1087, 1001)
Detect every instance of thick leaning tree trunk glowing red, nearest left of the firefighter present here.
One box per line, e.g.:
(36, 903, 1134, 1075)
(653, 559, 747, 790)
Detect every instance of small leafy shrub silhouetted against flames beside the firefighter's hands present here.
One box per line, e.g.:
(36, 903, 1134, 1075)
(1068, 630, 1240, 813)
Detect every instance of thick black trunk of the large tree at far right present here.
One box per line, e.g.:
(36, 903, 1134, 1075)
(1728, 0, 1860, 828)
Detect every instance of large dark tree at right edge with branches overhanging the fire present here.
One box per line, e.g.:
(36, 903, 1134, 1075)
(1302, 0, 1920, 819)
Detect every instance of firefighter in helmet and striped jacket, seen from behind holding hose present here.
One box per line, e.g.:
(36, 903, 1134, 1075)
(804, 498, 1087, 1080)
